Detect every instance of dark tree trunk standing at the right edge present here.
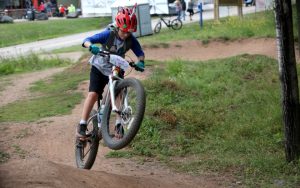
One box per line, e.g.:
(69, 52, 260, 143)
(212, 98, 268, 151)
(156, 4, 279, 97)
(275, 0, 300, 162)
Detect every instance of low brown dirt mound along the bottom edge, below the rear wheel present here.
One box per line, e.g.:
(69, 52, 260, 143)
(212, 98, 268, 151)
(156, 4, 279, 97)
(0, 159, 190, 188)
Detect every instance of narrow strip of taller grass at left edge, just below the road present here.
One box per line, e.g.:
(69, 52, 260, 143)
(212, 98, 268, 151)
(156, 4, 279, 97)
(0, 54, 71, 77)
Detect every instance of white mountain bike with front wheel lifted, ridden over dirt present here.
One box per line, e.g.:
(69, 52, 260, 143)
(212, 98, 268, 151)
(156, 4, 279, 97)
(75, 51, 146, 169)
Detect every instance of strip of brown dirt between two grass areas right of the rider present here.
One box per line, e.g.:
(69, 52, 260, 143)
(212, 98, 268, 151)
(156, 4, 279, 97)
(145, 38, 277, 61)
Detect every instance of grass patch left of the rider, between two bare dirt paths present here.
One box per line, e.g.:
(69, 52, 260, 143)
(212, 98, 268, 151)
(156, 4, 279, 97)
(0, 64, 89, 122)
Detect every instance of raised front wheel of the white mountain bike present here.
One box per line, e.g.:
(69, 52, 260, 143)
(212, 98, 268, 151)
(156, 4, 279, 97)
(101, 78, 146, 150)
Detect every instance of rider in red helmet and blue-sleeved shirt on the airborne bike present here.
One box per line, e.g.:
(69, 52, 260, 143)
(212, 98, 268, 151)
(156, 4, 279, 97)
(77, 7, 145, 139)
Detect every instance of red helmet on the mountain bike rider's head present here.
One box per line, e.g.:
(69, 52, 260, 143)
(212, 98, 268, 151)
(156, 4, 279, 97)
(116, 7, 137, 33)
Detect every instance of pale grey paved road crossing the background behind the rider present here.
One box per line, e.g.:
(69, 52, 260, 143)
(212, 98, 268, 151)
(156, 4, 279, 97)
(0, 7, 255, 58)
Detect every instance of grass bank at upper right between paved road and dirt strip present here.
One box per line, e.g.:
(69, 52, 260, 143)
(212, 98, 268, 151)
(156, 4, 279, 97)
(140, 11, 298, 46)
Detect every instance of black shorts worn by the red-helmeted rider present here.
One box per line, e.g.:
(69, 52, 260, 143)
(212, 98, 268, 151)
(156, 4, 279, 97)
(89, 66, 109, 96)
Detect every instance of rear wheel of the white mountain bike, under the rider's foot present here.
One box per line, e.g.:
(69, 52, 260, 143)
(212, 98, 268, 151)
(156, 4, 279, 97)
(75, 110, 101, 169)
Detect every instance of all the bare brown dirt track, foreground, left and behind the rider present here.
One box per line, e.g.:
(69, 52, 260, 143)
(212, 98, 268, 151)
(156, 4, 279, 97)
(0, 39, 292, 188)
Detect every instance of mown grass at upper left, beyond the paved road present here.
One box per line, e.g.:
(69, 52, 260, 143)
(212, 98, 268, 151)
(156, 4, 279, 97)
(0, 17, 111, 48)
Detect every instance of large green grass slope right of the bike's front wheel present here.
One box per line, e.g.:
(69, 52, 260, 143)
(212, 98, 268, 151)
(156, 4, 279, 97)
(122, 55, 300, 187)
